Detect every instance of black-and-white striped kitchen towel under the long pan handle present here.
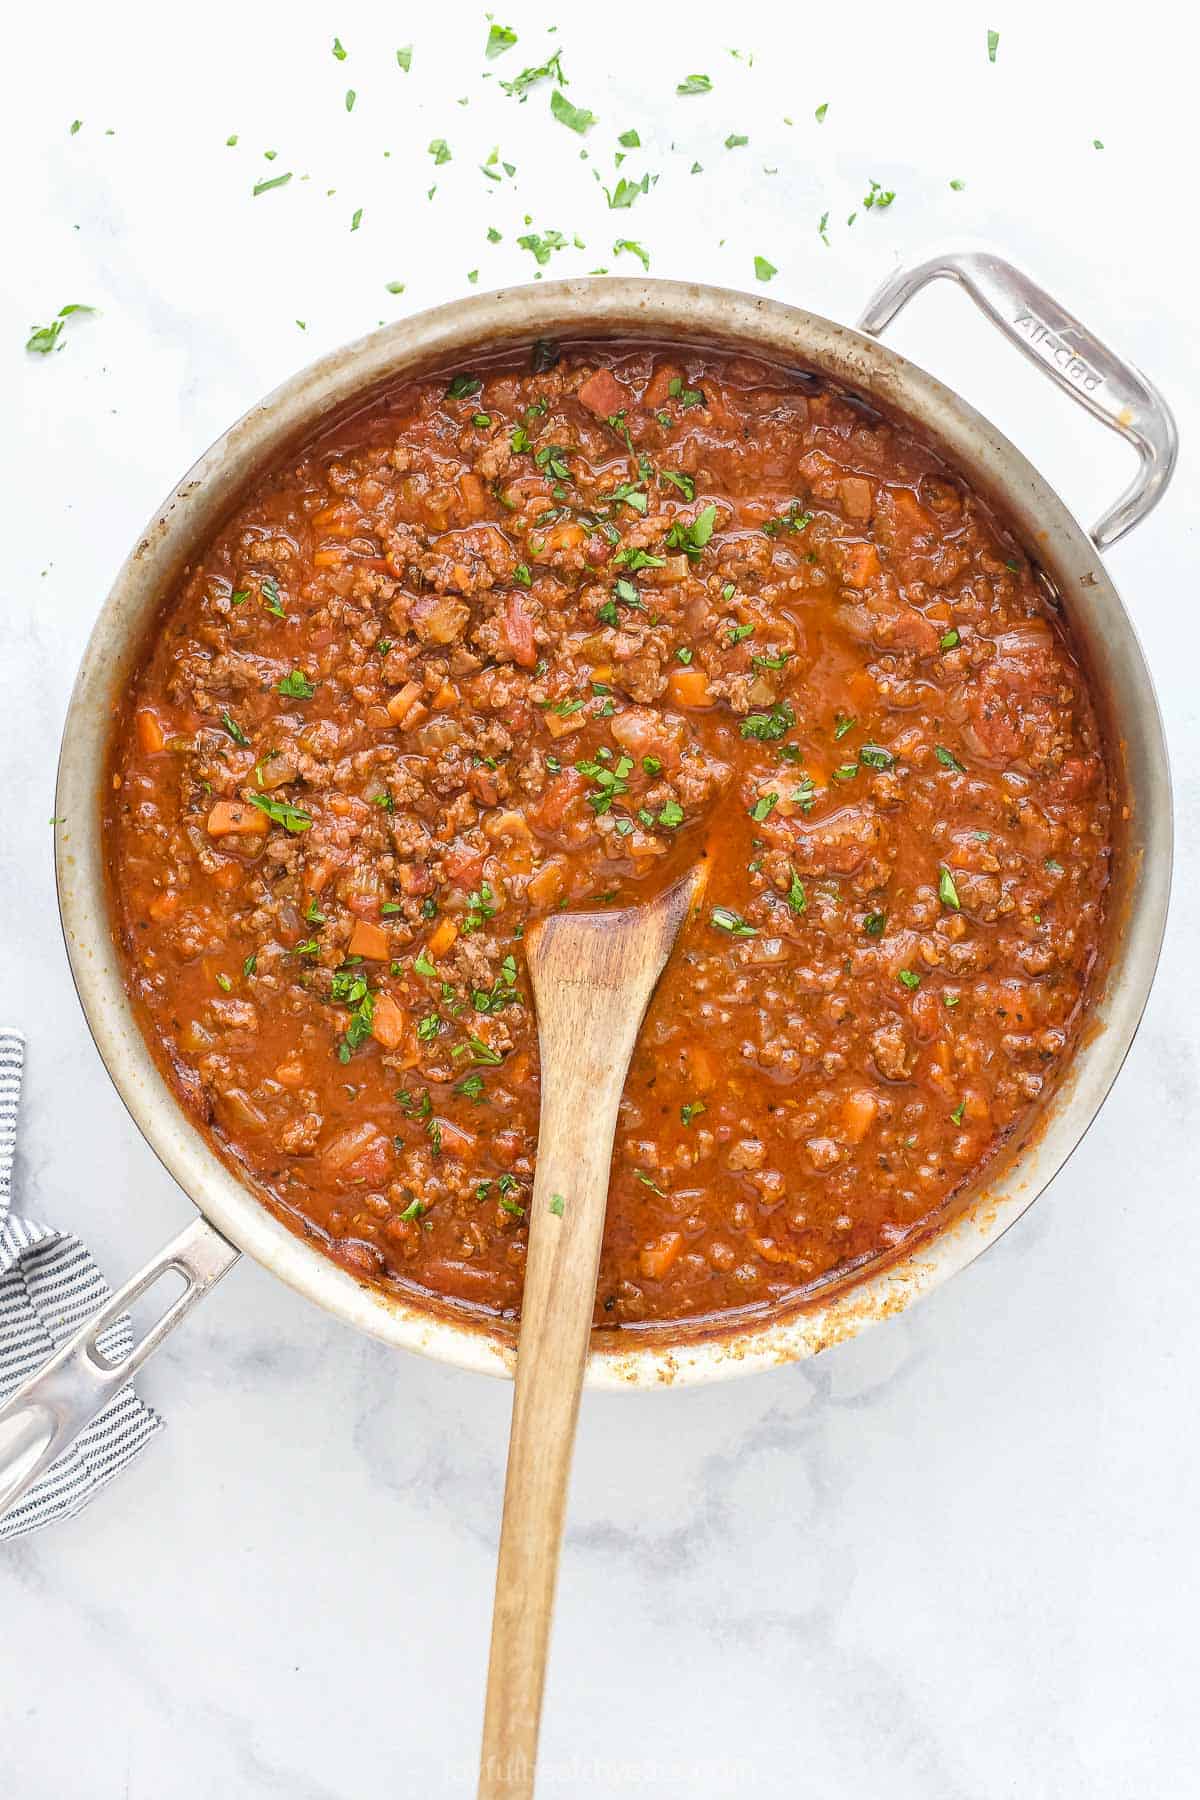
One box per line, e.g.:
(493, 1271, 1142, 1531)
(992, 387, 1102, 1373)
(0, 1026, 162, 1539)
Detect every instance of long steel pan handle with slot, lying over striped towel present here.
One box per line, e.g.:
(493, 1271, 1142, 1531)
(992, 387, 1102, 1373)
(0, 1219, 239, 1517)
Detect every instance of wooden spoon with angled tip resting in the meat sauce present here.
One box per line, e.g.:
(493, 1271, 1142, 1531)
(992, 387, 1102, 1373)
(479, 869, 703, 1800)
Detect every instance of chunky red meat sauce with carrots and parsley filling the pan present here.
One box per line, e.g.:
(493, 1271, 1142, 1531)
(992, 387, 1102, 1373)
(106, 344, 1110, 1328)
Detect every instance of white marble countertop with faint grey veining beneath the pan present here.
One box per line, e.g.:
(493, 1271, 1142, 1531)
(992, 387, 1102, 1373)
(0, 0, 1200, 1800)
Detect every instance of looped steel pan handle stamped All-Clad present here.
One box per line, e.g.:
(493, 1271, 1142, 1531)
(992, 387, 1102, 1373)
(858, 250, 1178, 551)
